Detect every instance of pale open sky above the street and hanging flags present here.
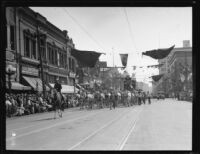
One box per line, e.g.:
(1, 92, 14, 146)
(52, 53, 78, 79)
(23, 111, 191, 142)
(30, 7, 192, 85)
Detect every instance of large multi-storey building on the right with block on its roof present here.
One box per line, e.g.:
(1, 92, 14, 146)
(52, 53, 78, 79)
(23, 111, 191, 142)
(154, 40, 192, 96)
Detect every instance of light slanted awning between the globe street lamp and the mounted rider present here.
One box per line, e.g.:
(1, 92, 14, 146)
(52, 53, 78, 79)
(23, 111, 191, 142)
(23, 76, 50, 91)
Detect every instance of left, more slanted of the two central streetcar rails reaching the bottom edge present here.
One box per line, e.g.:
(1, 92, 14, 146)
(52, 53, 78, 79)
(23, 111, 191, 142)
(67, 107, 139, 150)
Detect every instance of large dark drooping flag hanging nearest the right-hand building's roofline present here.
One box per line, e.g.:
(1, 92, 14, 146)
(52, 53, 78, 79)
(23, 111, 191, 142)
(142, 45, 175, 59)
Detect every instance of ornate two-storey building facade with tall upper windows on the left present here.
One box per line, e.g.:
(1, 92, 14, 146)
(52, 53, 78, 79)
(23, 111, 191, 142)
(6, 7, 77, 92)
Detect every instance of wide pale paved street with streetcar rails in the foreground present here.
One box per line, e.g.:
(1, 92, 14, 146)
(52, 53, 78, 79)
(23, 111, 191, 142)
(6, 99, 192, 150)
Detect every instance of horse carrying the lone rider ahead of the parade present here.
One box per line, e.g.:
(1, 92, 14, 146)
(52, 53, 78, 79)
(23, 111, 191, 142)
(50, 89, 64, 119)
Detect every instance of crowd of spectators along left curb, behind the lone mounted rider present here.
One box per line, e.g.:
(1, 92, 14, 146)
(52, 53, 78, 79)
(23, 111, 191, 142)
(5, 93, 77, 117)
